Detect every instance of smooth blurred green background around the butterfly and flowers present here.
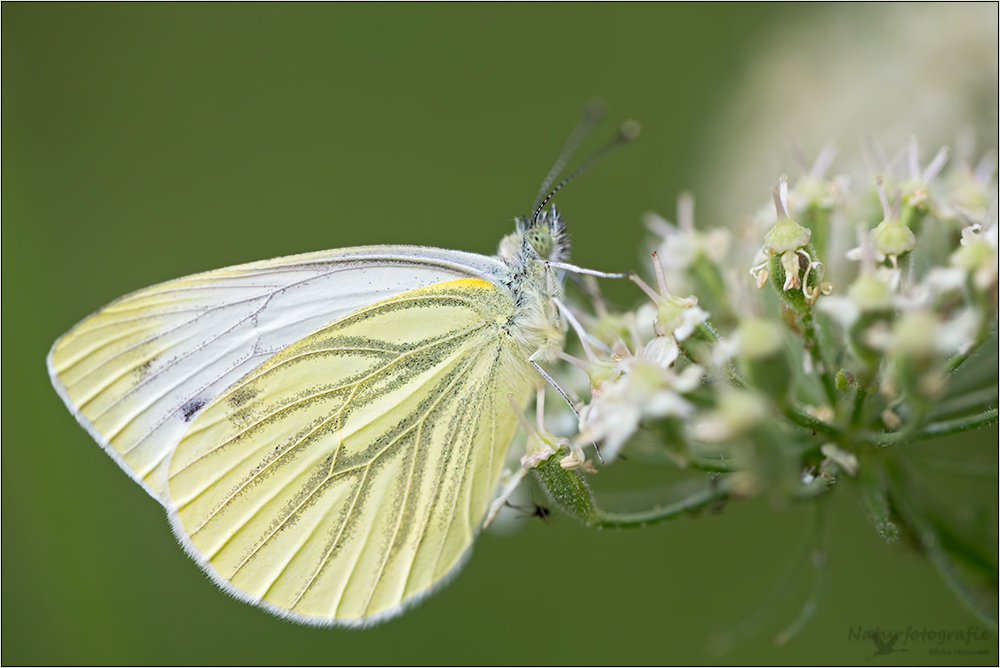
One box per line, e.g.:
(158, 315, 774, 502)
(2, 3, 997, 665)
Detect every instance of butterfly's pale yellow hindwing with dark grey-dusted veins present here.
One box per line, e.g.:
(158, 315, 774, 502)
(168, 279, 530, 625)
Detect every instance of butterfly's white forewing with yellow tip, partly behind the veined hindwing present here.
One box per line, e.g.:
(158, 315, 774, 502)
(48, 246, 504, 502)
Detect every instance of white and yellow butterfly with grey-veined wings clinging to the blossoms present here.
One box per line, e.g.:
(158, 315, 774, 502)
(48, 108, 632, 626)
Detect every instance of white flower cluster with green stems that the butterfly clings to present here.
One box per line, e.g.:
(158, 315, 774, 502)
(522, 139, 998, 636)
